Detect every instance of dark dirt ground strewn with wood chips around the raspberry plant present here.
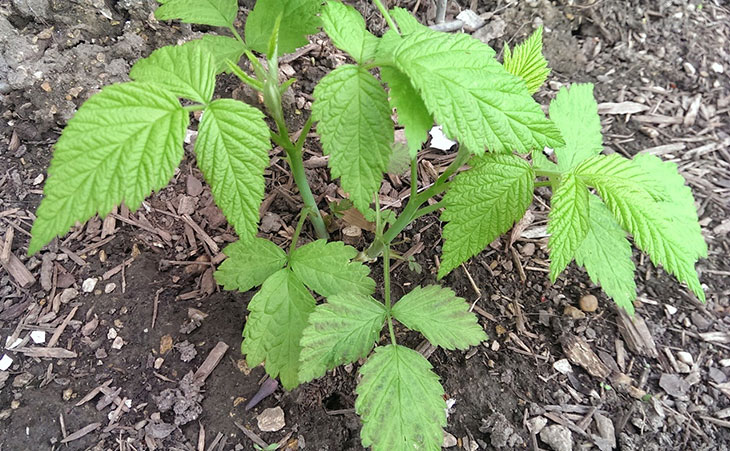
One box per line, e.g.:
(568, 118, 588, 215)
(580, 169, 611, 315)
(0, 0, 730, 451)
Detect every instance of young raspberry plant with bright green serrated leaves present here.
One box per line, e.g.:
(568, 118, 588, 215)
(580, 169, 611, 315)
(29, 0, 707, 450)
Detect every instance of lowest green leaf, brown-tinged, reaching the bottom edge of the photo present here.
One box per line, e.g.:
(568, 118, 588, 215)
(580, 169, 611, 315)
(355, 345, 446, 451)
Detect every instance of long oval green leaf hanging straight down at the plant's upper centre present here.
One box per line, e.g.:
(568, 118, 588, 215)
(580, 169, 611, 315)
(312, 64, 394, 212)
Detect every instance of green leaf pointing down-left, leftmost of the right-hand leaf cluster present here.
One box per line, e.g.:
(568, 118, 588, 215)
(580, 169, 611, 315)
(438, 154, 535, 278)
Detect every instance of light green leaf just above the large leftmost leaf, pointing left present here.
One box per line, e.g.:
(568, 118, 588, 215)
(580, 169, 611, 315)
(129, 42, 216, 103)
